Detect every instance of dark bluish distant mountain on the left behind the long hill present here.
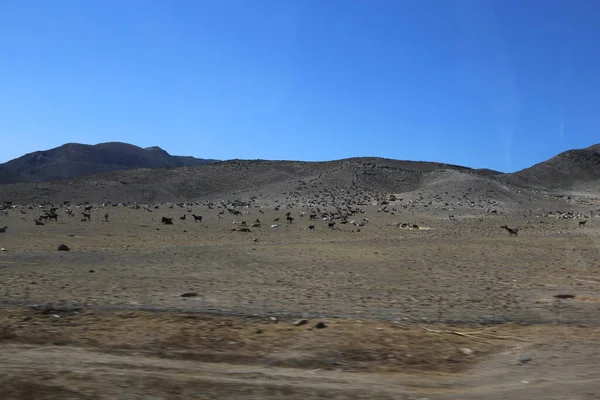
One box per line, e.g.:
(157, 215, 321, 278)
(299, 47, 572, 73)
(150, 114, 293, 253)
(0, 142, 217, 185)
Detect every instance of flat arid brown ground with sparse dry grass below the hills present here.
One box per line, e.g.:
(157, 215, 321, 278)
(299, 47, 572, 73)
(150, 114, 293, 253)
(0, 195, 600, 399)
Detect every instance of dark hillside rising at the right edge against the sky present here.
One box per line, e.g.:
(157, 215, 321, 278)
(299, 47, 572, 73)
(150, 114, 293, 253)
(503, 144, 600, 190)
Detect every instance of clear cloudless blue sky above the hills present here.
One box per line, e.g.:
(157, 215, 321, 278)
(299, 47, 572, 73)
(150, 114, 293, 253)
(0, 0, 600, 171)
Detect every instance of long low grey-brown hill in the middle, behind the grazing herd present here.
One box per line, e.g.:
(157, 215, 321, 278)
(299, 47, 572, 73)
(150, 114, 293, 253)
(0, 158, 534, 215)
